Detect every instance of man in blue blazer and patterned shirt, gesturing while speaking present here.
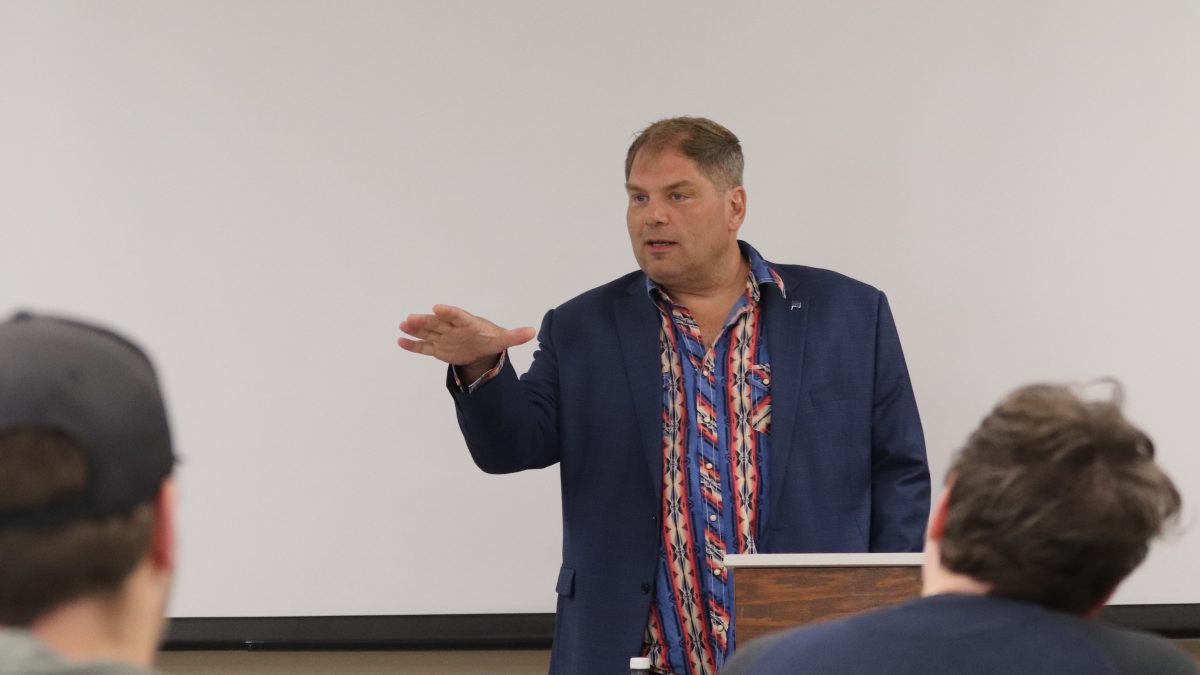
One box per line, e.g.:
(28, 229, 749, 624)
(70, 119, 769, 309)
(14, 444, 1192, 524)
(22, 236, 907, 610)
(400, 118, 929, 675)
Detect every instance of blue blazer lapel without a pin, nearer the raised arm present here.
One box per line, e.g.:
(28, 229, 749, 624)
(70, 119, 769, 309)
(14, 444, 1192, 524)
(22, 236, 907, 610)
(616, 275, 662, 490)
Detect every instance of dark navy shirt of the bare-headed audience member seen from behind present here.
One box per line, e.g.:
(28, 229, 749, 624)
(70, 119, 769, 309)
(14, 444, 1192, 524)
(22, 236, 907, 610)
(722, 596, 1196, 675)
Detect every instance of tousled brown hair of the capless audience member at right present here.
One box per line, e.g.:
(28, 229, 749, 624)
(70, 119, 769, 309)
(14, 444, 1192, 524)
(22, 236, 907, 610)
(940, 383, 1181, 613)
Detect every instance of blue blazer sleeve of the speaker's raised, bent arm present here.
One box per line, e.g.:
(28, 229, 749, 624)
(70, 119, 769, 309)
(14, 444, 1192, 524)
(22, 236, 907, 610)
(446, 310, 559, 473)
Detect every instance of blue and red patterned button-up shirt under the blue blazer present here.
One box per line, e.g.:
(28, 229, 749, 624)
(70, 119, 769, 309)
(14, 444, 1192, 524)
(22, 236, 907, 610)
(644, 243, 787, 675)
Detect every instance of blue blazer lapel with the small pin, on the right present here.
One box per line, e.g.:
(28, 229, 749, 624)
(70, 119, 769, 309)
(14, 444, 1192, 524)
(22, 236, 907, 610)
(760, 267, 809, 532)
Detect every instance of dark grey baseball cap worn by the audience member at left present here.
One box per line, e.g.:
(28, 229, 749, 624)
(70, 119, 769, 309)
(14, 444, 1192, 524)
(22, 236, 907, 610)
(0, 312, 175, 528)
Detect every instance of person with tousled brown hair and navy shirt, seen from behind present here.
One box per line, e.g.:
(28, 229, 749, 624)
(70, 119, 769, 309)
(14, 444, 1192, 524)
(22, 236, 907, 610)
(722, 384, 1198, 675)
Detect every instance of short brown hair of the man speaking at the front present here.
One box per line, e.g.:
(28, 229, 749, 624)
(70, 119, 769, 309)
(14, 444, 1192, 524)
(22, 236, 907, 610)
(625, 118, 745, 190)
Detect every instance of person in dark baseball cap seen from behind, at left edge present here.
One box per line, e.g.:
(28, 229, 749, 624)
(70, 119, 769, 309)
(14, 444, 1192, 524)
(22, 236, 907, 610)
(0, 313, 175, 675)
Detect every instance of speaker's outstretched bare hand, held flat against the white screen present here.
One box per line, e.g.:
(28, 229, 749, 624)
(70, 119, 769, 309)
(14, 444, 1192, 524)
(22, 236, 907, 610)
(396, 305, 536, 377)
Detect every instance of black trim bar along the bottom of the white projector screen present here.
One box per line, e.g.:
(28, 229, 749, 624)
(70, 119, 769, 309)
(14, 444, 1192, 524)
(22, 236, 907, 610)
(163, 604, 1200, 650)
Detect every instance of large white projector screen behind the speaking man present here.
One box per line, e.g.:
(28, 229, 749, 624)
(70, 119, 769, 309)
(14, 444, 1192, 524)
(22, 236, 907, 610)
(0, 0, 1200, 616)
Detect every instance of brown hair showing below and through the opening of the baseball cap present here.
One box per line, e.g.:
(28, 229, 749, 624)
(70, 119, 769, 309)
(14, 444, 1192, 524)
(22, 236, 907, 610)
(0, 430, 155, 626)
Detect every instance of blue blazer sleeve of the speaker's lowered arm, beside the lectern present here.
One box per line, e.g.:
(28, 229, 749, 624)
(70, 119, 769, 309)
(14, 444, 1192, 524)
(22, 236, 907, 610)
(870, 293, 929, 551)
